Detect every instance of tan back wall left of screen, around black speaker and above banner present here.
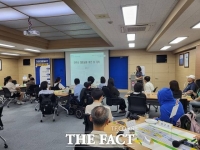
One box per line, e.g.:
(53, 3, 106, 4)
(18, 52, 65, 84)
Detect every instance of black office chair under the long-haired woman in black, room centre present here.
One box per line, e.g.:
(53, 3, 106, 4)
(102, 86, 126, 117)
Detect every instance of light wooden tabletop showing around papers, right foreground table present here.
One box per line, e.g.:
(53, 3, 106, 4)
(104, 117, 200, 150)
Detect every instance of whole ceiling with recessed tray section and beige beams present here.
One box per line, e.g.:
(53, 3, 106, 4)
(0, 0, 200, 55)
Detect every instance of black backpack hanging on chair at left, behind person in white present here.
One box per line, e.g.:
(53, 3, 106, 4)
(40, 94, 54, 114)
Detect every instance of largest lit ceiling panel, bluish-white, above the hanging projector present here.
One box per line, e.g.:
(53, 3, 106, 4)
(15, 2, 75, 17)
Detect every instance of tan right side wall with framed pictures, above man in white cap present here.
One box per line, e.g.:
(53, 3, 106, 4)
(175, 49, 197, 90)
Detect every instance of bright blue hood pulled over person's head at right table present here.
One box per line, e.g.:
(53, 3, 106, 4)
(158, 88, 175, 105)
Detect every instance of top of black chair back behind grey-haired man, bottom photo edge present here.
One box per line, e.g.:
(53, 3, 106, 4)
(74, 144, 124, 150)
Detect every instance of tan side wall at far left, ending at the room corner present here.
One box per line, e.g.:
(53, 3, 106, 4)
(0, 58, 19, 86)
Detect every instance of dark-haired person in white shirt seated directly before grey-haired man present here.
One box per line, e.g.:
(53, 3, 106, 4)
(85, 89, 113, 122)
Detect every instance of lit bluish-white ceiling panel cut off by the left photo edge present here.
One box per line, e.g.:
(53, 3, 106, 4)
(0, 8, 28, 21)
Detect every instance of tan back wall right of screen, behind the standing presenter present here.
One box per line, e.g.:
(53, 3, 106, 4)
(110, 50, 175, 89)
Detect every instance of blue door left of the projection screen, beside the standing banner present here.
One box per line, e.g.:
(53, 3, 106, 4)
(52, 58, 66, 86)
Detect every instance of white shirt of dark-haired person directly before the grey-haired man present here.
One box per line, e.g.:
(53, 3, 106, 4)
(85, 101, 113, 122)
